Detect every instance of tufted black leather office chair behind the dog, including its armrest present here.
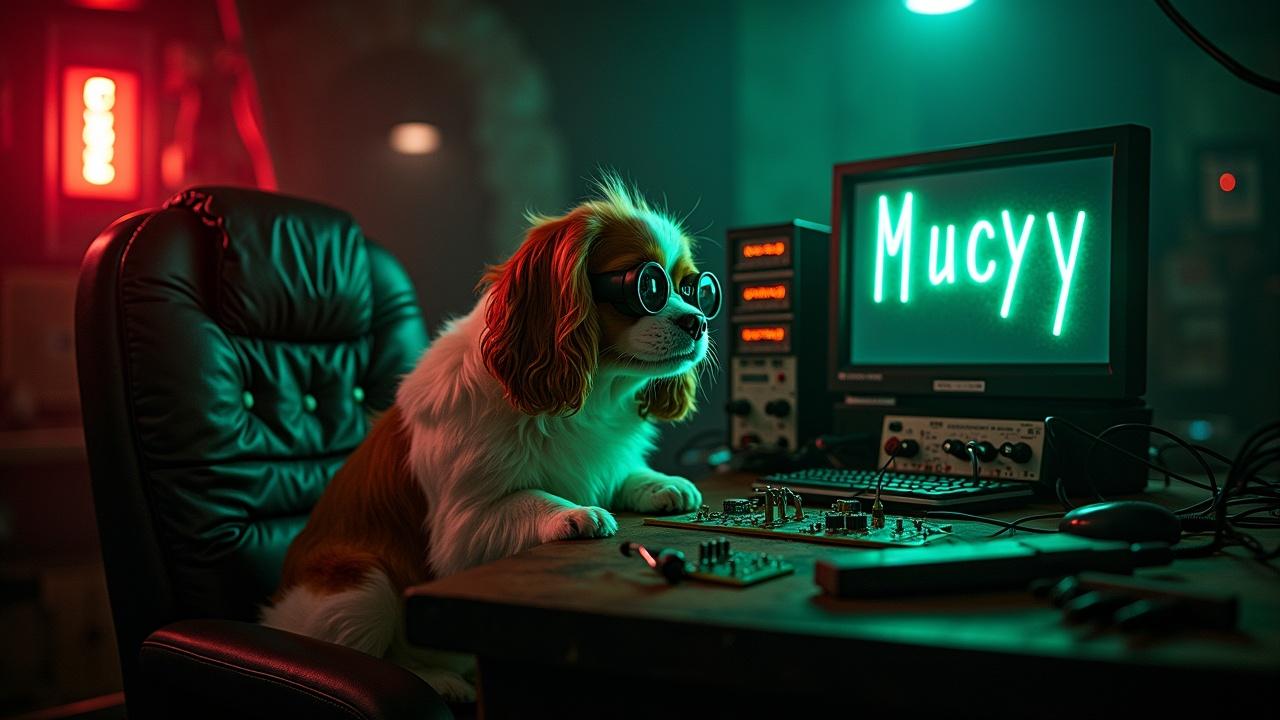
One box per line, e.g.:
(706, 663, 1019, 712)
(76, 187, 449, 719)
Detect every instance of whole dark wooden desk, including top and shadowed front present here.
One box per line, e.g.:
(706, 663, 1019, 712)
(407, 475, 1280, 717)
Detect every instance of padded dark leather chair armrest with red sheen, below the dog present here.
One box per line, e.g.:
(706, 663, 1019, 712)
(140, 619, 453, 720)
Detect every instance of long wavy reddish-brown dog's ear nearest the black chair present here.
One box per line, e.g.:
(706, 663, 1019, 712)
(480, 209, 600, 415)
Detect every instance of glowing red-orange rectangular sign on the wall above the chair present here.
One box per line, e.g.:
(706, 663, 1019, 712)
(61, 67, 140, 200)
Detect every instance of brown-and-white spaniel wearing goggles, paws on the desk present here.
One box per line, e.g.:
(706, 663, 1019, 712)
(262, 176, 721, 700)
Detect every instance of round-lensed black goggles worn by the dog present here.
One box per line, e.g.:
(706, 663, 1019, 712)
(591, 260, 723, 315)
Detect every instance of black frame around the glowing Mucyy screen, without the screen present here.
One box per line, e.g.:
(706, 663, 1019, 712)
(827, 124, 1151, 400)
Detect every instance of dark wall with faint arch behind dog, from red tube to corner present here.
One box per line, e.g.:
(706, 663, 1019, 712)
(243, 0, 736, 471)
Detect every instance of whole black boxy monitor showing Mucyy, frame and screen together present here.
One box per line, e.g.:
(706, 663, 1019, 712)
(829, 126, 1151, 400)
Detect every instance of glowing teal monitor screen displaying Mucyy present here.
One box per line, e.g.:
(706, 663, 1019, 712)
(846, 151, 1112, 365)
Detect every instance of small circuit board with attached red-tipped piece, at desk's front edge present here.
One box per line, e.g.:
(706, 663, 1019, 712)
(620, 537, 796, 587)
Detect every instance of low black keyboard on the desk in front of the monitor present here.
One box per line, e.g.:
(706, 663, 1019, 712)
(751, 468, 1032, 507)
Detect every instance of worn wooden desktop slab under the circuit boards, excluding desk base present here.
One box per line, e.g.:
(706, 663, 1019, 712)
(406, 475, 1280, 691)
